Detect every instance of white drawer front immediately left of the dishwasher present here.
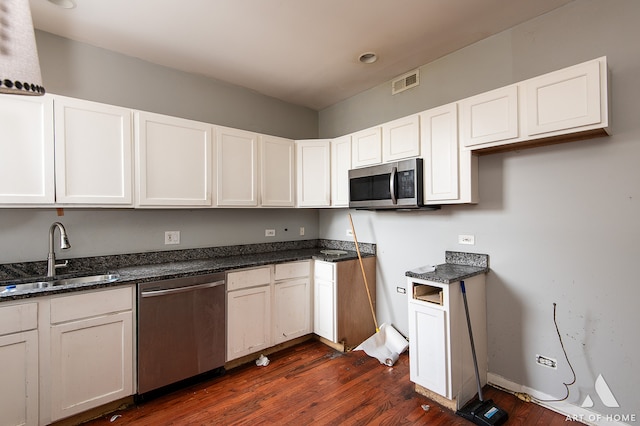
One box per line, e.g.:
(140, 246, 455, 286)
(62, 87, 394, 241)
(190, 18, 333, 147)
(51, 286, 133, 324)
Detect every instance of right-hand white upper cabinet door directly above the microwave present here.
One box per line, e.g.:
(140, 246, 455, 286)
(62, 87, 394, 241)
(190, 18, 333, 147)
(382, 114, 420, 163)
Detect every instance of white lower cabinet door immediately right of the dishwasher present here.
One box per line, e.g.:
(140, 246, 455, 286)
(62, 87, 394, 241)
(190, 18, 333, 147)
(227, 285, 271, 361)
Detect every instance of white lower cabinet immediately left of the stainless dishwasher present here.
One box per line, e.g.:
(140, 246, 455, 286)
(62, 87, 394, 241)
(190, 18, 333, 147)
(48, 287, 134, 421)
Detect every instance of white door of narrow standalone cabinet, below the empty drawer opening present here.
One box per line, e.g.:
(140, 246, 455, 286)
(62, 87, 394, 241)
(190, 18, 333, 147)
(409, 303, 451, 398)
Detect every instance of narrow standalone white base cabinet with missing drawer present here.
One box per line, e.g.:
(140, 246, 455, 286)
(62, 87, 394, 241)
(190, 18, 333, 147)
(407, 274, 488, 410)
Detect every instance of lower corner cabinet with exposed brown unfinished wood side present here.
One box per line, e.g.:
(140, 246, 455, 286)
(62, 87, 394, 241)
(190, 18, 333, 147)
(314, 257, 376, 350)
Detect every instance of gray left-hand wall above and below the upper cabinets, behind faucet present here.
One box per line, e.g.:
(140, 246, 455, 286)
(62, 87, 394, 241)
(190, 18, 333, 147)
(0, 31, 318, 263)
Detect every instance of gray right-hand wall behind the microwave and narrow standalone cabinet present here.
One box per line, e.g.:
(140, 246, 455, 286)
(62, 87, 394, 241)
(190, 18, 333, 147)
(320, 0, 640, 415)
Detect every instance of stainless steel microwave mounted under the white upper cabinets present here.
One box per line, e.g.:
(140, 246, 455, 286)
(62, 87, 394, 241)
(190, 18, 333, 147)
(349, 158, 439, 210)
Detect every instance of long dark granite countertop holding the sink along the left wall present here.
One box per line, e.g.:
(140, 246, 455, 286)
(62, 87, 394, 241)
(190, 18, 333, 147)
(0, 240, 375, 302)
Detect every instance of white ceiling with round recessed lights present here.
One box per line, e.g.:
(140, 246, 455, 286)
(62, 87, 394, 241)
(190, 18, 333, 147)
(30, 0, 572, 110)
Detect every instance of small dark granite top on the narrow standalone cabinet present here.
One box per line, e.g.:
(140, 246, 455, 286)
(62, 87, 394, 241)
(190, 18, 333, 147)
(405, 251, 489, 284)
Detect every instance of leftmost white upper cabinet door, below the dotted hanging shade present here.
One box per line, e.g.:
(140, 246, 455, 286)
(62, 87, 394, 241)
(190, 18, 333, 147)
(0, 95, 55, 204)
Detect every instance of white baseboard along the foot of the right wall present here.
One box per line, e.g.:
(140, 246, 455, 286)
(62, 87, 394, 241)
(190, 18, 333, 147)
(487, 373, 629, 426)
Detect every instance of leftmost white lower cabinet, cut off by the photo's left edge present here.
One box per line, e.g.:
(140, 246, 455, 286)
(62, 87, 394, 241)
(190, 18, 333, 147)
(0, 303, 39, 425)
